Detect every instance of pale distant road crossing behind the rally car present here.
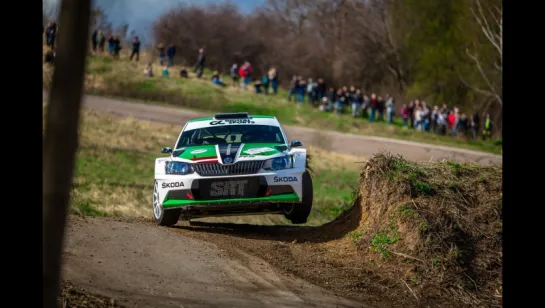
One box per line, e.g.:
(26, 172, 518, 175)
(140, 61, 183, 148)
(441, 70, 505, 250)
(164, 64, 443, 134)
(44, 92, 502, 165)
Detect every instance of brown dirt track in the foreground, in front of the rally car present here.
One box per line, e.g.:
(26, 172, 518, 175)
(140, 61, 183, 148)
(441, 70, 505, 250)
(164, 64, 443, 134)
(63, 216, 369, 307)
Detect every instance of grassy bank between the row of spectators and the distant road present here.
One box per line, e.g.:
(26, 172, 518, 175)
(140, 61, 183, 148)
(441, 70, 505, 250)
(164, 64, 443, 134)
(44, 57, 502, 154)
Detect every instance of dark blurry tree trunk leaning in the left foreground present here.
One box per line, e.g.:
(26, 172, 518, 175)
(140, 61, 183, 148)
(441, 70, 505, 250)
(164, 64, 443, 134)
(42, 0, 91, 308)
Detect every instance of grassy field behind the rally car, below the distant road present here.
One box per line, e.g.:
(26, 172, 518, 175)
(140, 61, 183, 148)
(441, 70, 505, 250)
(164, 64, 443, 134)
(62, 109, 359, 225)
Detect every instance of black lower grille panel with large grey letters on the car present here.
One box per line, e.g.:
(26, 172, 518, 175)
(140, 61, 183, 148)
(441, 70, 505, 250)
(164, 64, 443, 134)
(191, 176, 267, 200)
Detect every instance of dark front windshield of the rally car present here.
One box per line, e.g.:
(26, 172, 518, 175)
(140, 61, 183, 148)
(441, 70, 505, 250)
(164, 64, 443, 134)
(176, 125, 285, 149)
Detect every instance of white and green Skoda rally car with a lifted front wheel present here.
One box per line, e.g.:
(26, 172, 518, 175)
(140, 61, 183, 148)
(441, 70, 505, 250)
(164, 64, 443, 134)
(153, 113, 313, 226)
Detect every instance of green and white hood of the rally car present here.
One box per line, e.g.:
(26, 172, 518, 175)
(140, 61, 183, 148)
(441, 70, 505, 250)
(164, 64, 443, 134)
(172, 143, 288, 163)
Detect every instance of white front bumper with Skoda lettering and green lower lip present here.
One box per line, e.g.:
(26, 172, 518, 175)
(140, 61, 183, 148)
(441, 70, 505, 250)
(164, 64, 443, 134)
(156, 168, 304, 211)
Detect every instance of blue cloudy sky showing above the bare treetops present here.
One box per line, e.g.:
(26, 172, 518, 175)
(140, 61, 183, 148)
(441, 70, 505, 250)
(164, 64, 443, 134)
(43, 0, 264, 41)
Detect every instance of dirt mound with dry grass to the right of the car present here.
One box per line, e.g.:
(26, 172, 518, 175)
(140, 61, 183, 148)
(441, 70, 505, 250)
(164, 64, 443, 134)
(351, 154, 502, 307)
